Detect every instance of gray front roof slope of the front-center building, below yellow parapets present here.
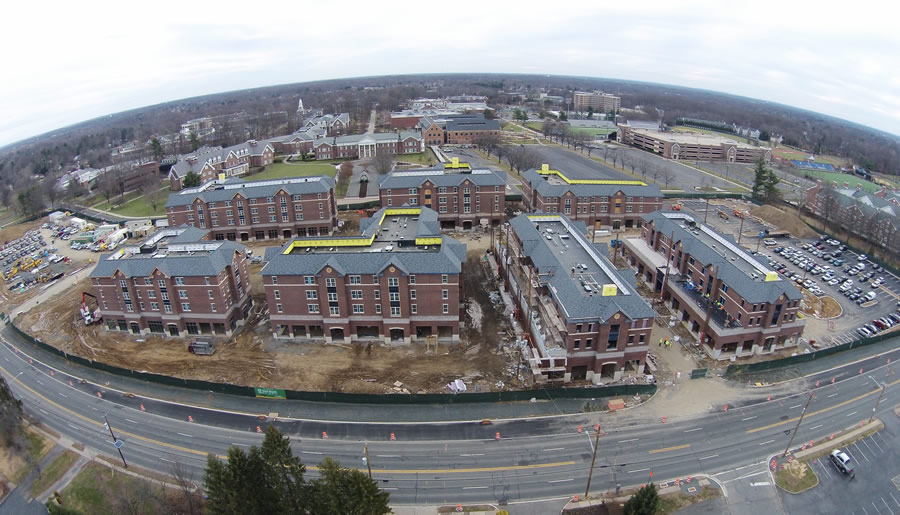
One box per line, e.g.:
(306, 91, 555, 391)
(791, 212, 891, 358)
(262, 236, 466, 276)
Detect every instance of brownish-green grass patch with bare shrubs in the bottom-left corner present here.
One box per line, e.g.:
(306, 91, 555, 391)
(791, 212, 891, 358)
(60, 463, 159, 515)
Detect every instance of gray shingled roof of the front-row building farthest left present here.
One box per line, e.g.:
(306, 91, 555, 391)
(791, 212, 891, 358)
(91, 241, 246, 277)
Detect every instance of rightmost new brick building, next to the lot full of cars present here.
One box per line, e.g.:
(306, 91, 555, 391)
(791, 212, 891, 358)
(624, 212, 805, 359)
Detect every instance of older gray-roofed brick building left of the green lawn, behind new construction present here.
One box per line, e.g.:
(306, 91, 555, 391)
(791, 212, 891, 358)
(169, 140, 275, 191)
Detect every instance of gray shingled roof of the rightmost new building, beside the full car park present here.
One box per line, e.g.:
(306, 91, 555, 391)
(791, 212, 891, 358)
(644, 211, 803, 303)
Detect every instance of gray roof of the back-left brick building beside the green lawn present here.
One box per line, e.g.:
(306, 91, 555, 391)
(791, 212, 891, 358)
(166, 175, 334, 207)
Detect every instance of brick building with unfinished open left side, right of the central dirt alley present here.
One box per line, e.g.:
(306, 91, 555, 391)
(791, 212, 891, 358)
(499, 214, 656, 382)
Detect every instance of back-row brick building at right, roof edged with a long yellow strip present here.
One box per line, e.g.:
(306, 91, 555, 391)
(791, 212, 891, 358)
(522, 164, 663, 230)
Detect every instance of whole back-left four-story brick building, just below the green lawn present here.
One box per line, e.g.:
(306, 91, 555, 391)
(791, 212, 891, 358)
(166, 175, 338, 241)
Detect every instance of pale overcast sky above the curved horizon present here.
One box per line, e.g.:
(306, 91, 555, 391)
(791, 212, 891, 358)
(0, 0, 900, 146)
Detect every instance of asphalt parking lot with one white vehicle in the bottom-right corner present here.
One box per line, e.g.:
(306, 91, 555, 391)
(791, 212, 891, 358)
(779, 413, 900, 515)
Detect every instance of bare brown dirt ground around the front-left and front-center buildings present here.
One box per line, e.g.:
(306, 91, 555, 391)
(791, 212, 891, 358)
(18, 233, 525, 393)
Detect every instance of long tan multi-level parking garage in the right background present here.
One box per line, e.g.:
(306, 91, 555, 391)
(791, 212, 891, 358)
(618, 123, 772, 163)
